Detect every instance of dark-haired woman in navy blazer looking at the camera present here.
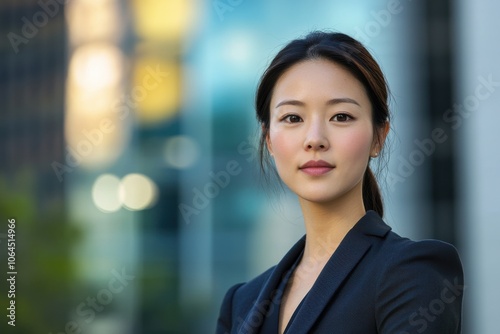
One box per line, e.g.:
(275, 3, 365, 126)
(217, 32, 463, 334)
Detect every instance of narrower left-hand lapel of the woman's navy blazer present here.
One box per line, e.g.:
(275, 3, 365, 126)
(237, 236, 306, 334)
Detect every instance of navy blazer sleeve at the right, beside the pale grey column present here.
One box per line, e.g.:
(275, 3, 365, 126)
(376, 240, 464, 334)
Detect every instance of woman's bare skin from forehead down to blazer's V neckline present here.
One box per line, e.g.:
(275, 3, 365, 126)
(267, 59, 389, 333)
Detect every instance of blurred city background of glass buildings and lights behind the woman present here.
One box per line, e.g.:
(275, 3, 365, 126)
(0, 0, 500, 334)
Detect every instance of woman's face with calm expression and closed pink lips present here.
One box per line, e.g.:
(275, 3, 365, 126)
(267, 59, 378, 203)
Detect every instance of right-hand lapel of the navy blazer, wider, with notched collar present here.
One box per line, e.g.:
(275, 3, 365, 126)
(288, 211, 391, 333)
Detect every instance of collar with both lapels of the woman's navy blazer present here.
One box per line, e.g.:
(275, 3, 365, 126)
(238, 210, 391, 334)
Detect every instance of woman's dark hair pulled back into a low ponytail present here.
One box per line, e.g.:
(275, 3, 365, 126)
(255, 31, 390, 217)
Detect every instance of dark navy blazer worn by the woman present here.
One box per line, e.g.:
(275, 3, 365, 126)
(216, 211, 464, 334)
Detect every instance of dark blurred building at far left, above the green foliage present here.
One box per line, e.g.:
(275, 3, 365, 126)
(0, 1, 67, 212)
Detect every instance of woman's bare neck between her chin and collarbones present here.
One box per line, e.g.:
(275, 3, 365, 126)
(299, 183, 366, 267)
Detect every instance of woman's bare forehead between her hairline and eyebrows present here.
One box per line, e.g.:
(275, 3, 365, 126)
(271, 58, 370, 107)
